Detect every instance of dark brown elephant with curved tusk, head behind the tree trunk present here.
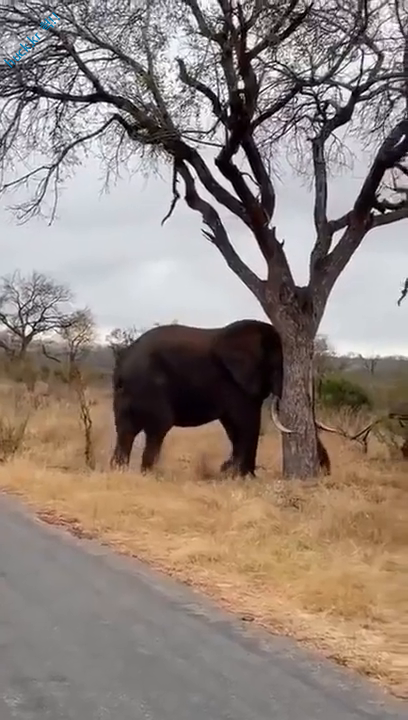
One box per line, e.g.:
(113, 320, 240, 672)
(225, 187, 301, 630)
(110, 320, 330, 476)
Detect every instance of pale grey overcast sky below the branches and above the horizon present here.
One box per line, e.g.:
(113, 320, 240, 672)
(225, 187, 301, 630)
(0, 150, 408, 355)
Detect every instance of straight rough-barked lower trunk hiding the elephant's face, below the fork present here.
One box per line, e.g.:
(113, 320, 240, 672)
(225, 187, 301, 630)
(281, 329, 320, 479)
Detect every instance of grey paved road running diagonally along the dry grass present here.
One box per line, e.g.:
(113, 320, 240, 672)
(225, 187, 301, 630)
(0, 495, 407, 720)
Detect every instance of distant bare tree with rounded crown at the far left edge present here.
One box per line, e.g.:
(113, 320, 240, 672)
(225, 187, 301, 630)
(0, 271, 72, 359)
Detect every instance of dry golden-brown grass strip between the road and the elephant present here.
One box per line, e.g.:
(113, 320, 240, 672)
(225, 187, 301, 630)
(0, 385, 408, 697)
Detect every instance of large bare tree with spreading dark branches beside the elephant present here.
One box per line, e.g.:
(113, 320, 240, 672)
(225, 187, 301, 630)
(0, 0, 408, 477)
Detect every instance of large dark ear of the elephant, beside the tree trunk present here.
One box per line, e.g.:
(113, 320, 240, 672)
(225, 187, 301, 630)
(213, 325, 263, 396)
